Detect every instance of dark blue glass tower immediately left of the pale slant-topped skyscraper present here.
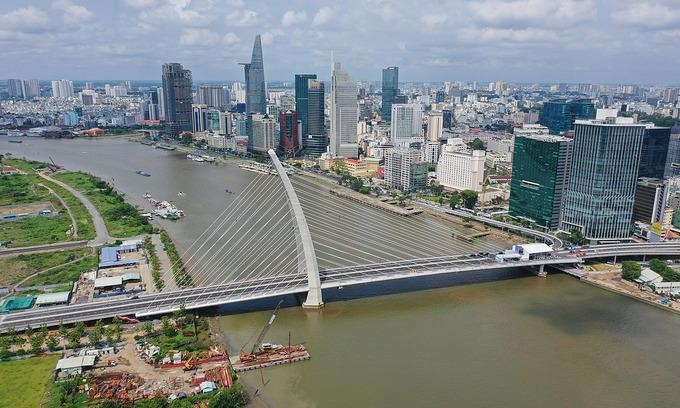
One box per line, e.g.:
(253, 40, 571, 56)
(302, 79, 328, 156)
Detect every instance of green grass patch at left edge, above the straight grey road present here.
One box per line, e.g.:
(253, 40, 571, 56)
(0, 215, 73, 248)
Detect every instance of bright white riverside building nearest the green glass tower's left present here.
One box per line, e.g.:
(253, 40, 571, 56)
(437, 138, 486, 191)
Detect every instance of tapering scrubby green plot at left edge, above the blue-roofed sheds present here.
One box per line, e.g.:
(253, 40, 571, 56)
(0, 248, 97, 286)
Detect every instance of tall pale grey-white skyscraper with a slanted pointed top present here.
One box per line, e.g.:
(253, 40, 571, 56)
(330, 62, 359, 159)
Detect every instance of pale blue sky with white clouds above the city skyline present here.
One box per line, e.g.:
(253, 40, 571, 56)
(0, 0, 680, 85)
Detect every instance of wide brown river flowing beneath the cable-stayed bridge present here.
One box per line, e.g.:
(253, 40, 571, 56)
(0, 138, 680, 408)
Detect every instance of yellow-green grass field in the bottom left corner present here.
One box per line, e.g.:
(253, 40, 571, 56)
(0, 354, 59, 408)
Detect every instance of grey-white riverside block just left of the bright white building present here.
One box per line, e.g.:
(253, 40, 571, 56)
(384, 148, 427, 191)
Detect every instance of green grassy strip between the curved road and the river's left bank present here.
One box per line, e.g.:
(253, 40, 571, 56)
(55, 172, 152, 238)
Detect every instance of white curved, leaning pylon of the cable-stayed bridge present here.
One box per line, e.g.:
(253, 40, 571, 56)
(267, 149, 323, 309)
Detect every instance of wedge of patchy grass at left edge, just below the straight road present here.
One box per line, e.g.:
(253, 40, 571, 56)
(0, 248, 92, 286)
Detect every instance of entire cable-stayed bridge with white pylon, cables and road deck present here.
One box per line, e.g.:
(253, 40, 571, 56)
(0, 152, 680, 330)
